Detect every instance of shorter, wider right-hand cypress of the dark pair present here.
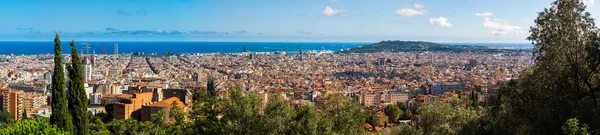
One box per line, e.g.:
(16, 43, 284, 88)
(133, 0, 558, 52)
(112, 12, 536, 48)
(68, 41, 89, 135)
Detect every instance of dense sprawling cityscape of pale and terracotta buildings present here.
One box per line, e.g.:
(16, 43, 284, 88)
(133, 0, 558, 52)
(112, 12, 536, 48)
(0, 44, 532, 120)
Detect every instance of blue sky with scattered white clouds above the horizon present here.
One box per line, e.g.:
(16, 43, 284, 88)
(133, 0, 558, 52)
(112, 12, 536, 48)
(0, 0, 600, 43)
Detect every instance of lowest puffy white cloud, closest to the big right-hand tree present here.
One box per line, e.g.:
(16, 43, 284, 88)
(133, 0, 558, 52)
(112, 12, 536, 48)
(483, 17, 523, 35)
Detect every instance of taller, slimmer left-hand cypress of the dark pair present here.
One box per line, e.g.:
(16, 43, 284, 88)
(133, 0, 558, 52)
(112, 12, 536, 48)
(50, 33, 74, 132)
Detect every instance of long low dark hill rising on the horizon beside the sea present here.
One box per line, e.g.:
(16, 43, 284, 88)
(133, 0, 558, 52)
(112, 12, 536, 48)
(340, 41, 514, 53)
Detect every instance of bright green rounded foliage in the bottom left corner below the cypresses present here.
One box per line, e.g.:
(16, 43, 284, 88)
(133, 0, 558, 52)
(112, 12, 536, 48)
(0, 117, 70, 135)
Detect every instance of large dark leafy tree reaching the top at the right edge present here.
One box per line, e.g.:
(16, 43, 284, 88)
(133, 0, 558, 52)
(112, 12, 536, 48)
(500, 0, 600, 134)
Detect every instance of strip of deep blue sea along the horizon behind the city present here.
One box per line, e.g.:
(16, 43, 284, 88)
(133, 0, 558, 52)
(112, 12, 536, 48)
(0, 41, 531, 55)
